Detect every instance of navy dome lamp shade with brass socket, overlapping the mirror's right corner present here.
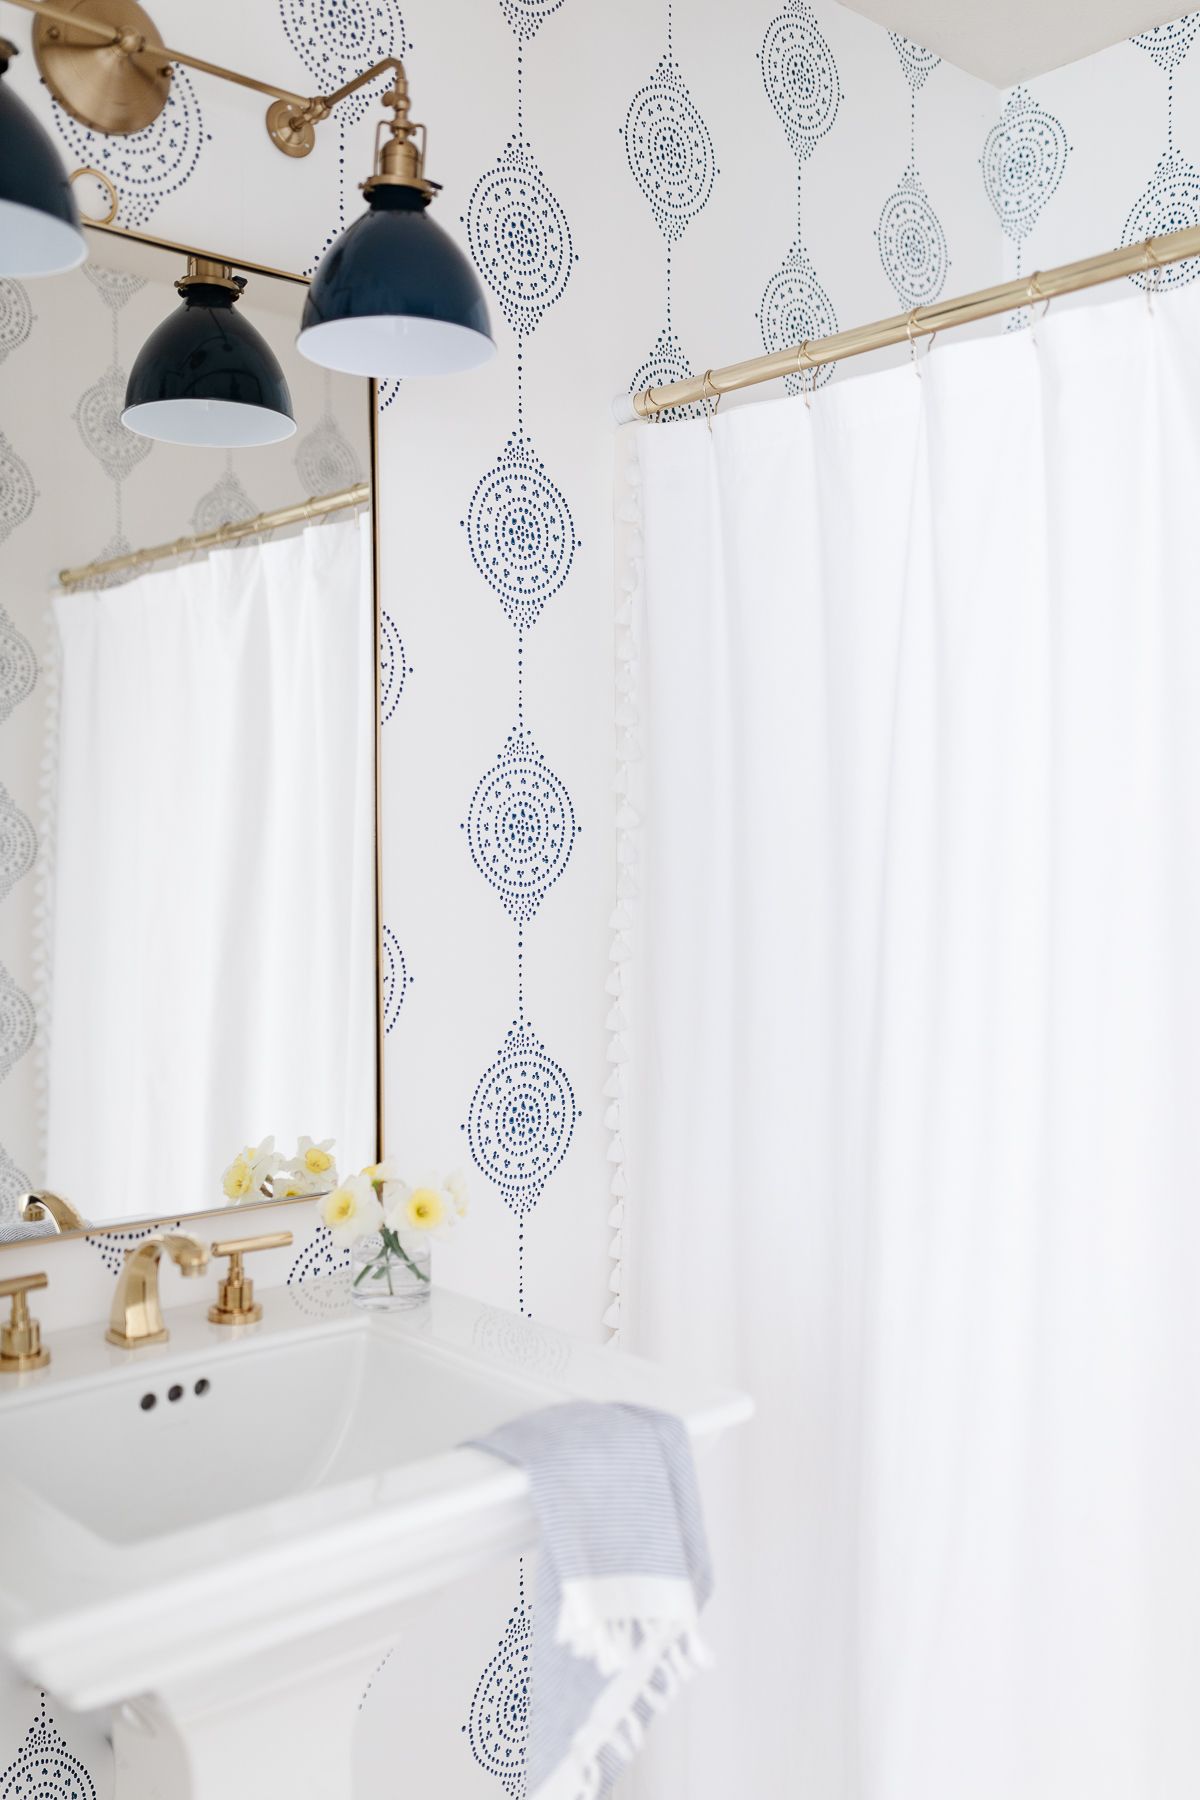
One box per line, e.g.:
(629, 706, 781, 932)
(297, 70, 497, 378)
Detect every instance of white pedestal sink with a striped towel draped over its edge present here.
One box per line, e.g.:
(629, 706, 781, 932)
(0, 1283, 750, 1800)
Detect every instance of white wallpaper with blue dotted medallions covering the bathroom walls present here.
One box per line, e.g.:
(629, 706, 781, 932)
(0, 0, 1200, 1800)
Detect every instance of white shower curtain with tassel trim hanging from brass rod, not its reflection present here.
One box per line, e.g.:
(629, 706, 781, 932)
(621, 288, 1200, 1800)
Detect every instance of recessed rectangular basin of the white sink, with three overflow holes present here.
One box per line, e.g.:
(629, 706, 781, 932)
(0, 1314, 538, 1544)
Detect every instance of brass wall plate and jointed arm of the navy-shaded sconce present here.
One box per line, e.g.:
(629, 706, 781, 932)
(9, 0, 413, 158)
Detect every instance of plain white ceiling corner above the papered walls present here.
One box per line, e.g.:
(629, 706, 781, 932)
(842, 0, 1180, 88)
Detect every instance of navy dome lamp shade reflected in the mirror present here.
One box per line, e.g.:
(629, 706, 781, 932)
(121, 256, 295, 450)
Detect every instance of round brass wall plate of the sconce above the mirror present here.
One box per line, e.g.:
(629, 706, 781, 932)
(32, 0, 171, 137)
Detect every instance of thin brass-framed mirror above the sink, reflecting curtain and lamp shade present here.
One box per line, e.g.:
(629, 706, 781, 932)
(0, 229, 380, 1242)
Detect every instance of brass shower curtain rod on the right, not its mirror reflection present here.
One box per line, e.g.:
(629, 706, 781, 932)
(617, 225, 1200, 419)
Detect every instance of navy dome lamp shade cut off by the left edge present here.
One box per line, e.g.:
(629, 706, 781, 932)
(0, 38, 88, 275)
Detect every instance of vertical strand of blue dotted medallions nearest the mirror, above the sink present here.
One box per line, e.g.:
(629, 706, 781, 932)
(462, 4, 579, 1312)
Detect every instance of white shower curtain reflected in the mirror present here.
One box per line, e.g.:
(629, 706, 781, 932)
(40, 520, 374, 1219)
